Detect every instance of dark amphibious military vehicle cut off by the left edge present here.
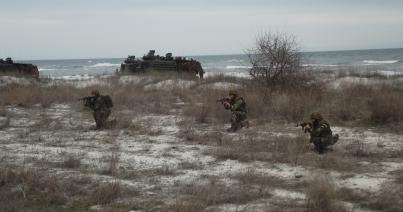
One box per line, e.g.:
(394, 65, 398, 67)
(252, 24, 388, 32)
(0, 57, 39, 79)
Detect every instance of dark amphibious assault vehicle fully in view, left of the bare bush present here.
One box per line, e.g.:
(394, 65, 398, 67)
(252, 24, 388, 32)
(120, 50, 204, 78)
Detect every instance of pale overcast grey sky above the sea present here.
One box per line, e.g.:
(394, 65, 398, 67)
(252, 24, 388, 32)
(0, 0, 403, 60)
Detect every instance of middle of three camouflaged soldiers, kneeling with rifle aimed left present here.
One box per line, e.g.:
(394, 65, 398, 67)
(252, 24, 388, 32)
(221, 91, 249, 132)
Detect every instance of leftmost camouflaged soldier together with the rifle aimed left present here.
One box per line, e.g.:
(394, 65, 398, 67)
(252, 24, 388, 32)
(81, 90, 113, 129)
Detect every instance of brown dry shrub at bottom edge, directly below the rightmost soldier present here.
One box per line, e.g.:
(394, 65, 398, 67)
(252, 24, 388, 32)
(305, 176, 347, 212)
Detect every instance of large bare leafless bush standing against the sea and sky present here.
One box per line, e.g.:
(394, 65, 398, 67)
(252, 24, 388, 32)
(247, 33, 308, 89)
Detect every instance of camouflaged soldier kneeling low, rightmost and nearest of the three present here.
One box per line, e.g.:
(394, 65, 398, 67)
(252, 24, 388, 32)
(305, 112, 339, 154)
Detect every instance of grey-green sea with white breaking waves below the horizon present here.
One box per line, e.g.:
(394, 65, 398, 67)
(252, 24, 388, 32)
(18, 48, 403, 79)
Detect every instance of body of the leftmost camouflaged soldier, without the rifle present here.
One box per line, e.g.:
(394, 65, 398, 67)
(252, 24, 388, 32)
(89, 90, 111, 129)
